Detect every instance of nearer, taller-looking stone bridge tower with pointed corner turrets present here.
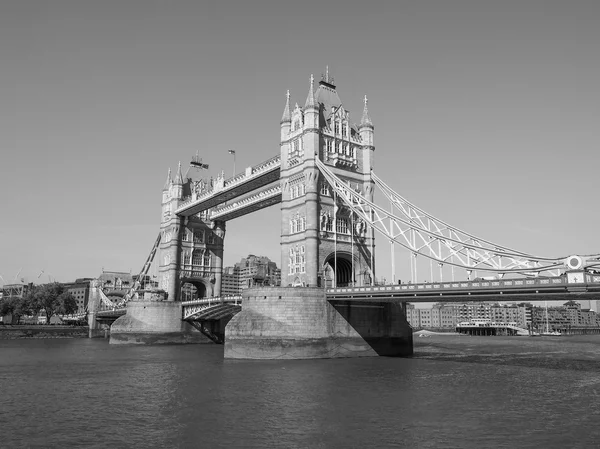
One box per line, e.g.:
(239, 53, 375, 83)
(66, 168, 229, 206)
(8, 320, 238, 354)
(280, 70, 375, 287)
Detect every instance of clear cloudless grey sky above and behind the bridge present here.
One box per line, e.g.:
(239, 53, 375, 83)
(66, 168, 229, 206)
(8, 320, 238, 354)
(0, 0, 600, 284)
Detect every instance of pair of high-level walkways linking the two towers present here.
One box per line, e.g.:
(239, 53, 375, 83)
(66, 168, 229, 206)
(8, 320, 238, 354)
(175, 155, 281, 217)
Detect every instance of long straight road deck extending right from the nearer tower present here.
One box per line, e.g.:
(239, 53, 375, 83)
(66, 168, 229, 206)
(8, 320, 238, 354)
(326, 272, 600, 303)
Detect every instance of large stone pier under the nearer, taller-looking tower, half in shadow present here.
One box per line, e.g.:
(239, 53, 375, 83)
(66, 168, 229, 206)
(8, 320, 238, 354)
(225, 287, 413, 359)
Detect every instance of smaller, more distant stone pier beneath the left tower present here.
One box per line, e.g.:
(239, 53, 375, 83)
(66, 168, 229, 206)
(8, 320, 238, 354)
(109, 301, 212, 345)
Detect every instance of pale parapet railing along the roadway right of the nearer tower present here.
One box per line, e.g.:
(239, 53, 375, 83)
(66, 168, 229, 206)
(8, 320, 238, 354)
(326, 273, 600, 294)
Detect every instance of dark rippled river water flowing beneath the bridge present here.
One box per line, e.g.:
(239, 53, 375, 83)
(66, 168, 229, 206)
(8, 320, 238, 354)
(0, 335, 600, 449)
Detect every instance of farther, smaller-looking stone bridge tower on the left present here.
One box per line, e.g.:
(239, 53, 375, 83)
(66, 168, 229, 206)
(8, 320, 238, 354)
(158, 163, 225, 301)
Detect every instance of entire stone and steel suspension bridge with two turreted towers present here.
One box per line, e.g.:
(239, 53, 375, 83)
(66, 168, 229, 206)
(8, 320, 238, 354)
(88, 71, 600, 358)
